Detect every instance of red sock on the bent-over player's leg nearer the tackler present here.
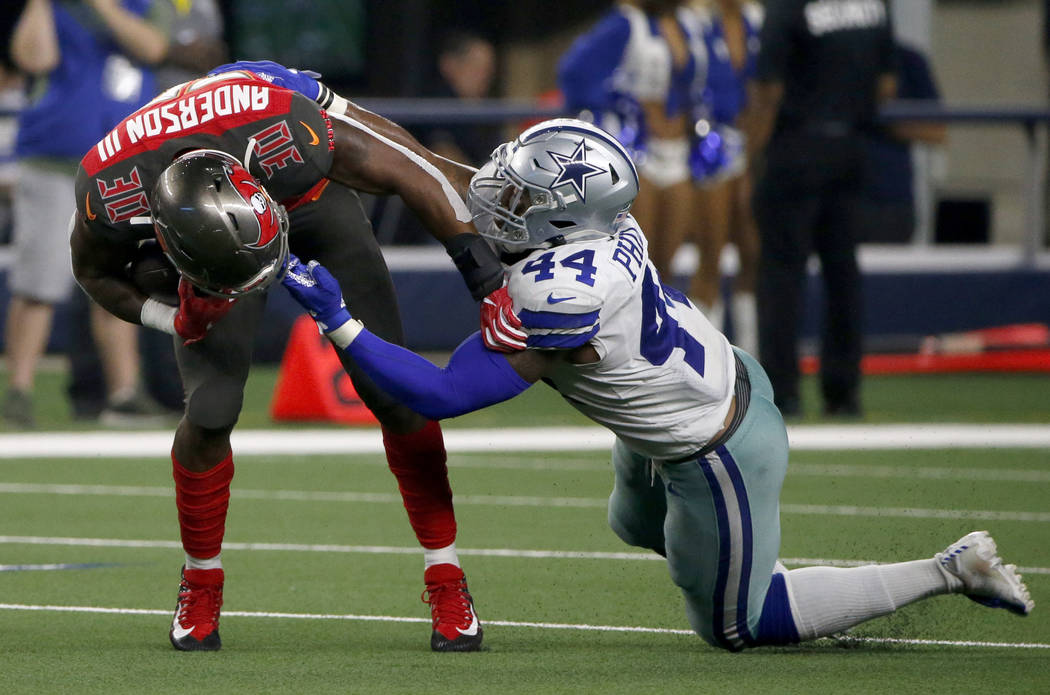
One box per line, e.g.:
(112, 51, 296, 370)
(383, 420, 456, 548)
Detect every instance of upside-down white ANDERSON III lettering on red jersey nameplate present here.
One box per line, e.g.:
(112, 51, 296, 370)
(97, 84, 270, 162)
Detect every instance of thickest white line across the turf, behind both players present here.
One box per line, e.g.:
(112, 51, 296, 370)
(0, 424, 1050, 459)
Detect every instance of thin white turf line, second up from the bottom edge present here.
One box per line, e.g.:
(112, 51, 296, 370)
(0, 535, 1050, 574)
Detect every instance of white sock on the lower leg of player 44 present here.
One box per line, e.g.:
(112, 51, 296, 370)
(784, 559, 950, 640)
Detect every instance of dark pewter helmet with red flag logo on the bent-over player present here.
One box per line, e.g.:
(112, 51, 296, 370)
(151, 150, 289, 298)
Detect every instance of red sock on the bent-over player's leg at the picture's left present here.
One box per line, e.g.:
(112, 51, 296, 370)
(171, 451, 233, 560)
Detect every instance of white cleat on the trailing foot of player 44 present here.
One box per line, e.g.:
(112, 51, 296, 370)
(933, 531, 1035, 615)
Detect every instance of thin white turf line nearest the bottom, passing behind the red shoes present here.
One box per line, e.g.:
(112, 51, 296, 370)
(0, 604, 1050, 649)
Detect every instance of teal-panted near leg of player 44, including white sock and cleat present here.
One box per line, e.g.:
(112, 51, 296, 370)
(657, 353, 1034, 650)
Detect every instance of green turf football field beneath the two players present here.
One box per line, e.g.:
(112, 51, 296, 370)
(0, 370, 1050, 693)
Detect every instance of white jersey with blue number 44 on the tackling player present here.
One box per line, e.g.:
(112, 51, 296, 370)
(507, 217, 736, 460)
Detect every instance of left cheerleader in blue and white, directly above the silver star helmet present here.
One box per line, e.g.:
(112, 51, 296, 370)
(559, 0, 705, 278)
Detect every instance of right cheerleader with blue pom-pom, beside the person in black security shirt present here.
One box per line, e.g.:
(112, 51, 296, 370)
(689, 0, 762, 354)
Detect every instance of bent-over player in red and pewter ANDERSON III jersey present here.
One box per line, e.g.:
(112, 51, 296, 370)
(70, 63, 502, 651)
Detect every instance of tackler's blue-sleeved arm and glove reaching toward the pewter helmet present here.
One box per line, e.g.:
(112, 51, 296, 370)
(281, 256, 557, 420)
